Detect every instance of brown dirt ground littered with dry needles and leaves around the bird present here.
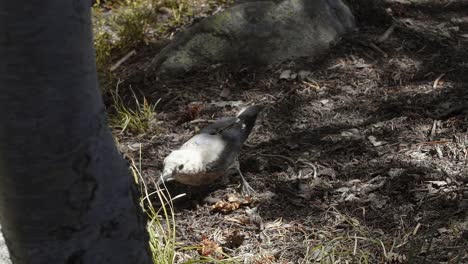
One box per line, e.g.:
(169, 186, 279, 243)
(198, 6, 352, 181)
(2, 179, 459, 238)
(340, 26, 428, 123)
(112, 1, 468, 263)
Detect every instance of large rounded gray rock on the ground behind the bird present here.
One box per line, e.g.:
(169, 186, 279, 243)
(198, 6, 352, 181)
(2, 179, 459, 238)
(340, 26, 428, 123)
(153, 0, 355, 73)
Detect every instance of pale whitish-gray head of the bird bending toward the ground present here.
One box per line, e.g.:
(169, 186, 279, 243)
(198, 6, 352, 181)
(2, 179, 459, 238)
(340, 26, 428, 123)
(158, 150, 204, 184)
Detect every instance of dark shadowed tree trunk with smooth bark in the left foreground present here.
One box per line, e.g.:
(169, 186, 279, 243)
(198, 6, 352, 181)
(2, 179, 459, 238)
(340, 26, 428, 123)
(0, 0, 151, 264)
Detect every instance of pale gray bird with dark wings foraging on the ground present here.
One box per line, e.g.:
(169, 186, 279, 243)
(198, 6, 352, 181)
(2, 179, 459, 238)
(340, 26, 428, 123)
(157, 105, 263, 195)
